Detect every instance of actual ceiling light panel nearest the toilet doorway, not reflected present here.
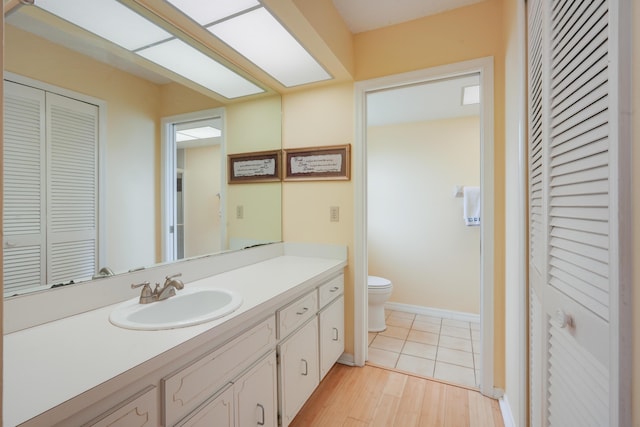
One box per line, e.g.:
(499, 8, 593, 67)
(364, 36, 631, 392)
(207, 7, 331, 87)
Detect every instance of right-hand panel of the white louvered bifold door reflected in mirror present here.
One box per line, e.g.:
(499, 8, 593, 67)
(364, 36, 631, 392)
(46, 93, 98, 283)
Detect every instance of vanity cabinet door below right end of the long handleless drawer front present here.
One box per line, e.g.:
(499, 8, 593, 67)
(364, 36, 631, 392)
(234, 351, 278, 427)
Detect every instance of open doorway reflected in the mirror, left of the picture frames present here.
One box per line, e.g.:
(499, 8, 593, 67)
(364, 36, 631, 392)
(162, 109, 226, 262)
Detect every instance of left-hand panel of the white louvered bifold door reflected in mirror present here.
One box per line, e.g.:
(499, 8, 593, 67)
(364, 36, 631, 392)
(3, 81, 46, 295)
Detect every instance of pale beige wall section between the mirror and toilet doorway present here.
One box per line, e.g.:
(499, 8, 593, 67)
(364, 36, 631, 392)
(282, 83, 354, 354)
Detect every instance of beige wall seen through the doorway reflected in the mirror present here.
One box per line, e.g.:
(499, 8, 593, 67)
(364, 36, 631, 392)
(182, 145, 221, 258)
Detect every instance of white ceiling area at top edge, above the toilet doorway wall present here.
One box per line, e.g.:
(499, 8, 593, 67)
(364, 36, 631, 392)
(333, 0, 482, 34)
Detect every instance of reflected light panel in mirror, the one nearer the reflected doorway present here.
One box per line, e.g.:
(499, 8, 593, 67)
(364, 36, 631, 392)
(136, 39, 264, 99)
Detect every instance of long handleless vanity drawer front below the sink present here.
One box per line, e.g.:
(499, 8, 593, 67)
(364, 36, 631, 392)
(162, 316, 276, 425)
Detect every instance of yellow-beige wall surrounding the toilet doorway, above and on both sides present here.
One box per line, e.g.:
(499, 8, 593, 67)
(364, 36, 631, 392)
(283, 0, 505, 387)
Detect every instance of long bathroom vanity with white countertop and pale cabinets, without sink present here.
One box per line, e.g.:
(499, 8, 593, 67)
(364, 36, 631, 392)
(4, 244, 346, 427)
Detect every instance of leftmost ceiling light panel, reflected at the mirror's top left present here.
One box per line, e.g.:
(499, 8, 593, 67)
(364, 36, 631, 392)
(35, 0, 173, 50)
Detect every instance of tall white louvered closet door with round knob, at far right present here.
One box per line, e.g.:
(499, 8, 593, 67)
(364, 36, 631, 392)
(527, 0, 618, 427)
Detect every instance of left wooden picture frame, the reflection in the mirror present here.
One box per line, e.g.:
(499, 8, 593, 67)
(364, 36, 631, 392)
(227, 150, 282, 184)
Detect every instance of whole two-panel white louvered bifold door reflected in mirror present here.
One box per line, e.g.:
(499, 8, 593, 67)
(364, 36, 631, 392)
(3, 81, 98, 295)
